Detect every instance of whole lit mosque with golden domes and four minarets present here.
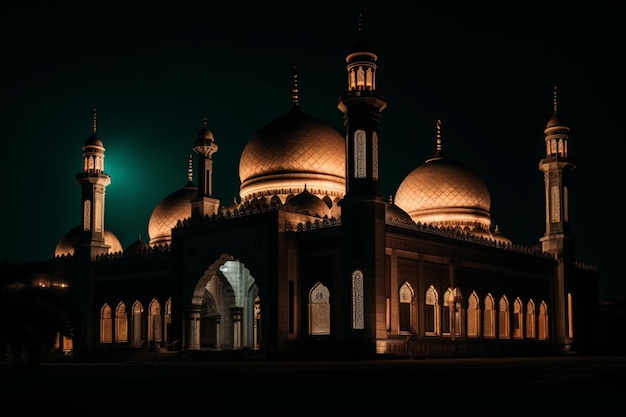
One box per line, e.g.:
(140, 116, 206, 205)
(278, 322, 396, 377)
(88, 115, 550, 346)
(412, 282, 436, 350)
(4, 11, 598, 358)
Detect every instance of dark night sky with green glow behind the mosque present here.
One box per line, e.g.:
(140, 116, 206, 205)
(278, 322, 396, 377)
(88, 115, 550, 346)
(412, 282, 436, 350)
(0, 1, 626, 296)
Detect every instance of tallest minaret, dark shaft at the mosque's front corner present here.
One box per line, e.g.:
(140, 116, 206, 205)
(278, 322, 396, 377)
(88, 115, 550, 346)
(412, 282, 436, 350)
(338, 12, 387, 349)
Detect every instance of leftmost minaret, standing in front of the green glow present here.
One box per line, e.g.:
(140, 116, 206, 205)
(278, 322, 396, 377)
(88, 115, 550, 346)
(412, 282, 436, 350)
(76, 109, 111, 258)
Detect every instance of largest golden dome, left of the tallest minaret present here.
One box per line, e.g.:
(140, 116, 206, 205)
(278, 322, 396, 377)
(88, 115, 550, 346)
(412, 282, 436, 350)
(239, 106, 346, 202)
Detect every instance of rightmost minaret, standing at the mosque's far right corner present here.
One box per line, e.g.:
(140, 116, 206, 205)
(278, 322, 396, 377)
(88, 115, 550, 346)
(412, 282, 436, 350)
(539, 86, 576, 350)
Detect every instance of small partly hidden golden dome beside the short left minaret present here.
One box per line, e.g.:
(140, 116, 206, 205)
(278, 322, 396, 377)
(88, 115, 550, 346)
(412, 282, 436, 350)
(148, 182, 198, 246)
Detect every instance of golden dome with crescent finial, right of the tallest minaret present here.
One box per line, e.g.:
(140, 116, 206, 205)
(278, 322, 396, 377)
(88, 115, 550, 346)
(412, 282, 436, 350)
(395, 156, 491, 230)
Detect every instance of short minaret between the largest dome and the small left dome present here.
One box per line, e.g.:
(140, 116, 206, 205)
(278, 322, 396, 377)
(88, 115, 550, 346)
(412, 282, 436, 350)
(191, 114, 220, 218)
